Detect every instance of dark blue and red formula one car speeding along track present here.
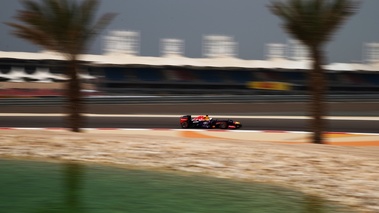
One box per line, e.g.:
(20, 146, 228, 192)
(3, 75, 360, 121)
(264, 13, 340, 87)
(180, 115, 242, 129)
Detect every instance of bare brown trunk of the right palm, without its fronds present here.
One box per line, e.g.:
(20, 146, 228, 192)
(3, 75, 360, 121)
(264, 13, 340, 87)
(309, 46, 326, 144)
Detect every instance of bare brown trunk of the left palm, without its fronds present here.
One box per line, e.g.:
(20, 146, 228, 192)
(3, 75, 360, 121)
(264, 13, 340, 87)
(66, 59, 83, 132)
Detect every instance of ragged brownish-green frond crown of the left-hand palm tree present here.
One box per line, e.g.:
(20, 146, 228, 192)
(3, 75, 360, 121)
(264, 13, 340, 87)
(6, 0, 115, 55)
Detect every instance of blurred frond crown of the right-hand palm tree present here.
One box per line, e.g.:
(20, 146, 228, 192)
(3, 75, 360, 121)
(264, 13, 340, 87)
(269, 0, 357, 44)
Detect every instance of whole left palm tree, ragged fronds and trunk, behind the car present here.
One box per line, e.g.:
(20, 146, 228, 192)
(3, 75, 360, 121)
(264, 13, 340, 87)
(6, 0, 115, 132)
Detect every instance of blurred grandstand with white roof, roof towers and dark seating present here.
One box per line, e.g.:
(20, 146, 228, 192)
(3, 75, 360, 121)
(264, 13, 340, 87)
(0, 31, 379, 95)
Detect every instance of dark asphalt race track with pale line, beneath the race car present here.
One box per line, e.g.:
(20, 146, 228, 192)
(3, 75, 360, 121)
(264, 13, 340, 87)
(0, 103, 379, 133)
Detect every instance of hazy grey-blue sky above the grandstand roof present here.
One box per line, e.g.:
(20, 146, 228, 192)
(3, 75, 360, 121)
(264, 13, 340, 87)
(0, 0, 379, 62)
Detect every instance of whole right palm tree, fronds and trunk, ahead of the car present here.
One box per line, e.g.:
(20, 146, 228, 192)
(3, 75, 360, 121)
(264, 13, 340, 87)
(269, 0, 357, 144)
